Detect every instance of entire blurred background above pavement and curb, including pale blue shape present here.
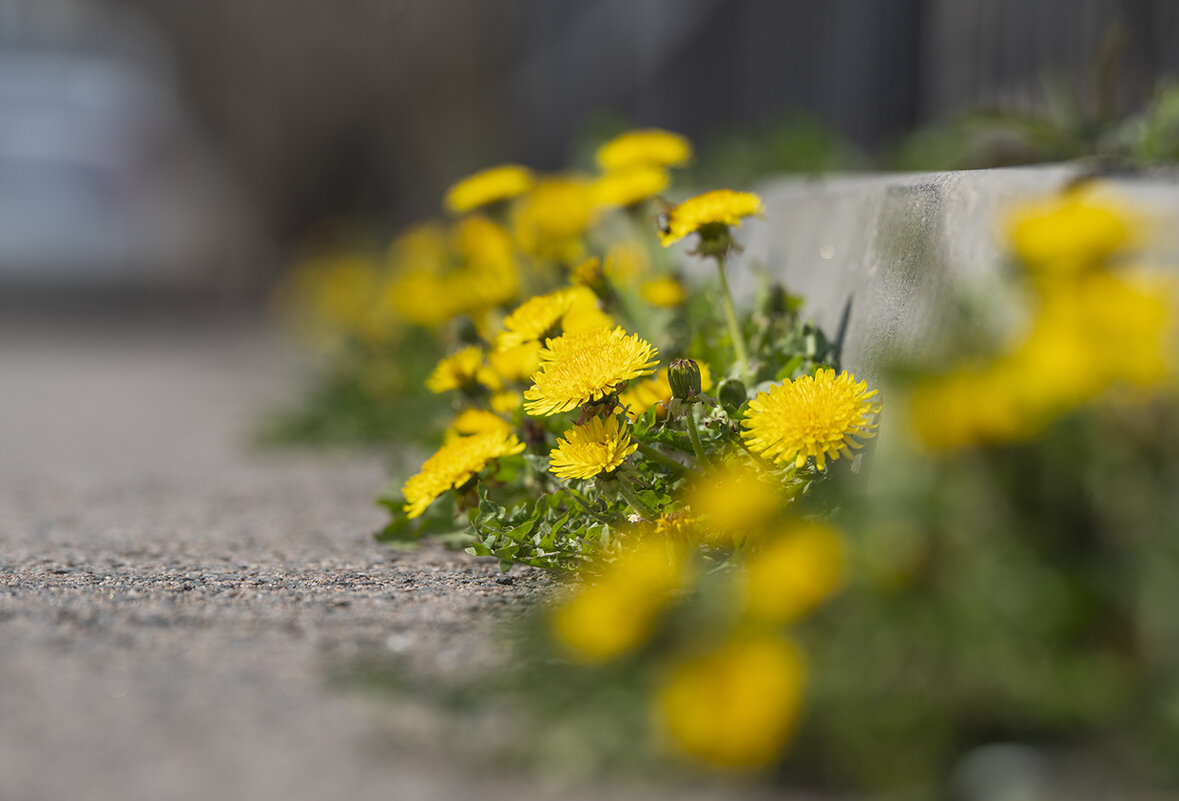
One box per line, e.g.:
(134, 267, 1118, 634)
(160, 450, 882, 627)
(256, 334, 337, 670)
(0, 0, 1179, 304)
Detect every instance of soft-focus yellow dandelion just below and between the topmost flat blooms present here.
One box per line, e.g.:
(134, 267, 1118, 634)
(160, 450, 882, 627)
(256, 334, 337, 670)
(512, 176, 597, 263)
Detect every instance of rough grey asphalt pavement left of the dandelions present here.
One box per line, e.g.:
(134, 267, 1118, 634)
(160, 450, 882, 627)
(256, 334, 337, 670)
(0, 324, 763, 801)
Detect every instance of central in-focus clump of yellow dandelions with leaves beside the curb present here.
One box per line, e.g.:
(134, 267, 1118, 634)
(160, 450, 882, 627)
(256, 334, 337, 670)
(372, 130, 877, 569)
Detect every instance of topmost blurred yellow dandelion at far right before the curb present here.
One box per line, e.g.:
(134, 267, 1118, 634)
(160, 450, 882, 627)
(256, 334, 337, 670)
(1008, 188, 1134, 274)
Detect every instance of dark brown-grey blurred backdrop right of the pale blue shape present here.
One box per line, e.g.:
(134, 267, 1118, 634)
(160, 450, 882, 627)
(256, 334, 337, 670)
(0, 0, 1179, 287)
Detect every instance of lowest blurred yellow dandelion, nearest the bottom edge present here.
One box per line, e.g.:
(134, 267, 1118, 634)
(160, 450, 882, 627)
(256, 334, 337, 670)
(654, 636, 804, 770)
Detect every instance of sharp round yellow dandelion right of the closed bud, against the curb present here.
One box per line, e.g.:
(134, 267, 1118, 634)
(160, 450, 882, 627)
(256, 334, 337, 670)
(742, 368, 880, 470)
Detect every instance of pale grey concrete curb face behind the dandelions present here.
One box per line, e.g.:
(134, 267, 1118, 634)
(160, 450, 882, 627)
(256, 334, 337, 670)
(731, 164, 1179, 385)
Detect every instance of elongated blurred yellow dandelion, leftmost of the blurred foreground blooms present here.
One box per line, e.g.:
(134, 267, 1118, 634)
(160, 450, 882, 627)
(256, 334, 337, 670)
(552, 539, 685, 663)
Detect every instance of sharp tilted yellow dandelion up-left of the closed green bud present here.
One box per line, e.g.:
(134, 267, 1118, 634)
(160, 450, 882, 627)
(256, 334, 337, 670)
(523, 327, 659, 416)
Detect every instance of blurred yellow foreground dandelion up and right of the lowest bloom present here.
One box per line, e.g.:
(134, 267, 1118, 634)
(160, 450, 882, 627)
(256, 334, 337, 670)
(745, 520, 845, 623)
